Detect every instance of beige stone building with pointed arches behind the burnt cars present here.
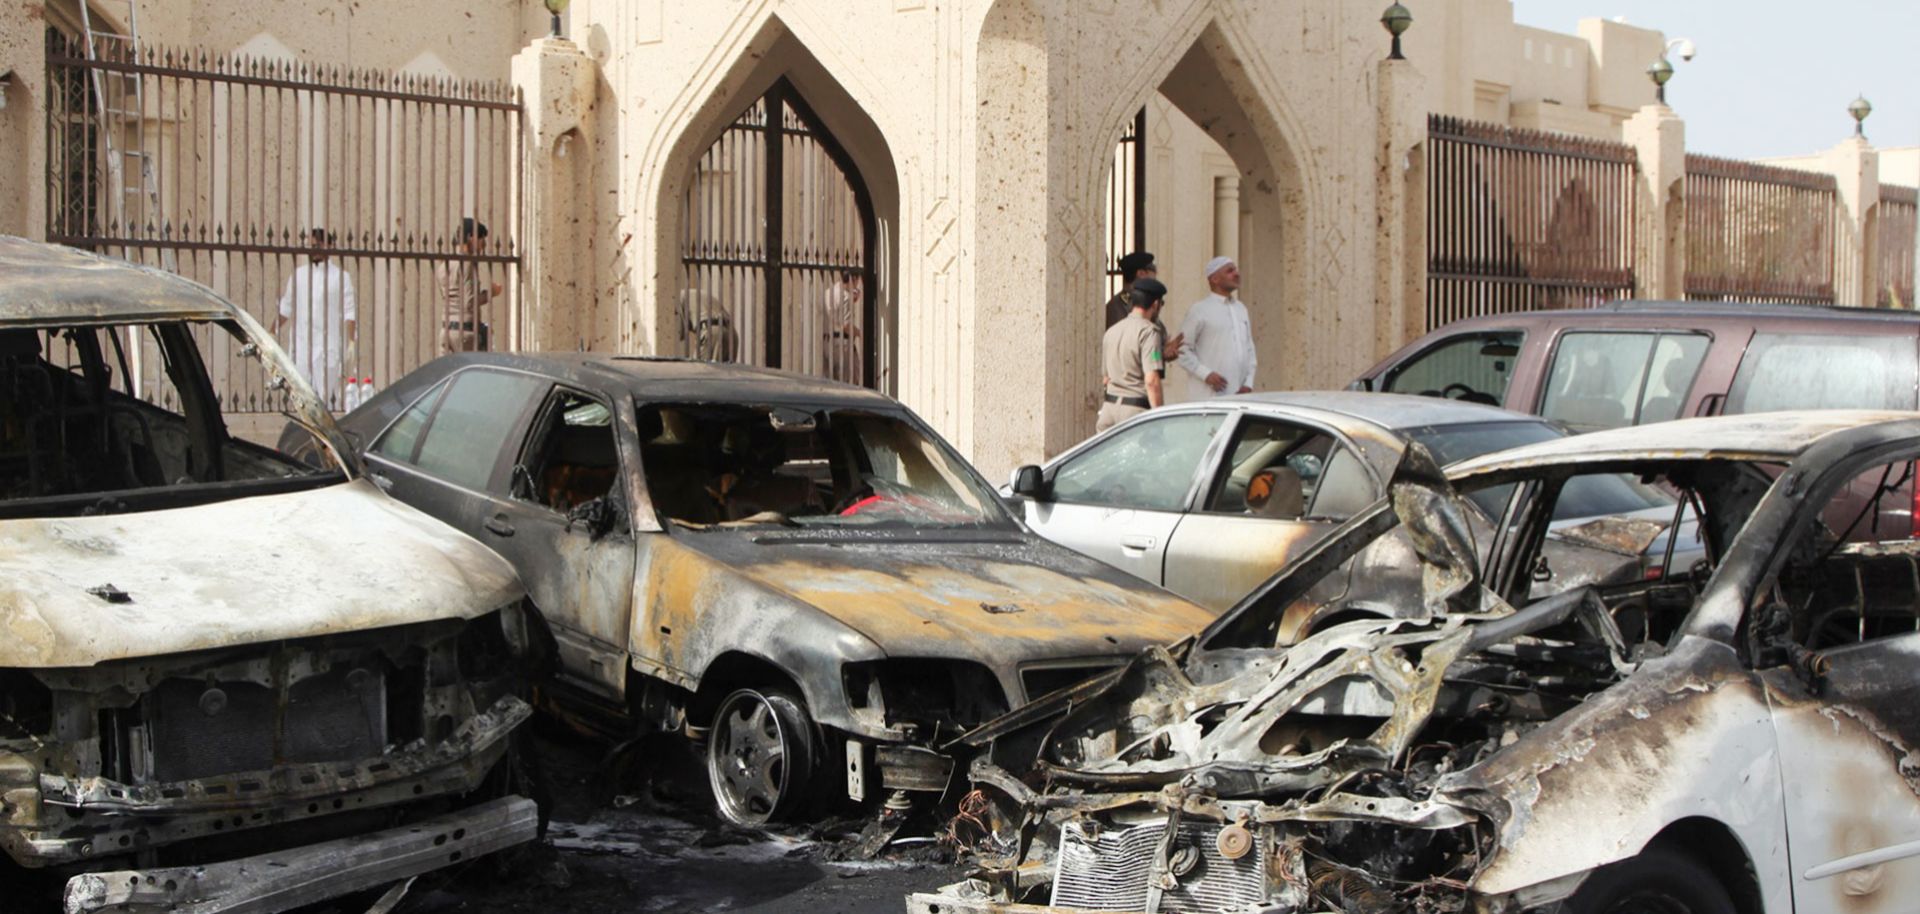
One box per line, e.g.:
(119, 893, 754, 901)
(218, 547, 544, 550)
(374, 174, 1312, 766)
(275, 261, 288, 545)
(0, 0, 1896, 474)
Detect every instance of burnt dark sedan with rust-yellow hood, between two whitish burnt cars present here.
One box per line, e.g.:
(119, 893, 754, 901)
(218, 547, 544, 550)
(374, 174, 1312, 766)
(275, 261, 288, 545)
(322, 353, 1215, 824)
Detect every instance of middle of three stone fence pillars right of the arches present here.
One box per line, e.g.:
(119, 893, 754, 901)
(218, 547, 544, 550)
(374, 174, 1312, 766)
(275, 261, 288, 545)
(1622, 102, 1686, 301)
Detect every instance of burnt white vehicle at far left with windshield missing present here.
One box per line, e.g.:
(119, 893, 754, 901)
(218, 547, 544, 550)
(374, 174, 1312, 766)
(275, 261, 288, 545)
(0, 238, 538, 914)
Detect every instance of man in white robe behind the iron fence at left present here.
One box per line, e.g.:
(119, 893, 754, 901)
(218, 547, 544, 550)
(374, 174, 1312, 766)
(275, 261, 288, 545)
(273, 229, 359, 409)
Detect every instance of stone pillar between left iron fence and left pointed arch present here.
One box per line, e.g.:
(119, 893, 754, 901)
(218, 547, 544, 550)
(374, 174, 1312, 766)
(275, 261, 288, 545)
(513, 38, 597, 351)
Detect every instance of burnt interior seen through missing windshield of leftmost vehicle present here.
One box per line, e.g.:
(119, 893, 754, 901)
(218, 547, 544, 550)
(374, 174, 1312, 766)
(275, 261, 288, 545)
(0, 323, 340, 517)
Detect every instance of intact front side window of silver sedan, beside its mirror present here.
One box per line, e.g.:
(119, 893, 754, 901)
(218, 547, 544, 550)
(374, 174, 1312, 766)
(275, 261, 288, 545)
(1054, 413, 1221, 511)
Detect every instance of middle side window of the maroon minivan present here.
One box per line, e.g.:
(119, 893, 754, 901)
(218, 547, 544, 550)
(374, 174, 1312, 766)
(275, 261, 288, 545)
(1540, 332, 1709, 432)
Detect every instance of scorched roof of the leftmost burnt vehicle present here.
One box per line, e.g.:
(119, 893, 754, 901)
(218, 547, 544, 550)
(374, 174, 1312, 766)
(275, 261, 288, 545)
(0, 236, 236, 326)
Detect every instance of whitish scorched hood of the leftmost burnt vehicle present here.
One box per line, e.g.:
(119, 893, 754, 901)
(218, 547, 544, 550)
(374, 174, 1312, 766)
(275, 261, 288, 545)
(0, 480, 522, 668)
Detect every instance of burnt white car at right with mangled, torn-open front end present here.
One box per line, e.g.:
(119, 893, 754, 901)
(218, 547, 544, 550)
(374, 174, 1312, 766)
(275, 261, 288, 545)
(908, 413, 1920, 914)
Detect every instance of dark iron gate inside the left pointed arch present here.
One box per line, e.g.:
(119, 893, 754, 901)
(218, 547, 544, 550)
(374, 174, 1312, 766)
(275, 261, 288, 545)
(680, 79, 877, 386)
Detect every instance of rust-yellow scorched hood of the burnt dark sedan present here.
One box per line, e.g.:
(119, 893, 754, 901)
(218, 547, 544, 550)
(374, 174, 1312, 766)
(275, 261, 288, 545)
(682, 532, 1213, 661)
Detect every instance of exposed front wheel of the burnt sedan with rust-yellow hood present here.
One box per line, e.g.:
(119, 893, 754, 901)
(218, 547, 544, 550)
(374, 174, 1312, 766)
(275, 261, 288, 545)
(707, 689, 814, 826)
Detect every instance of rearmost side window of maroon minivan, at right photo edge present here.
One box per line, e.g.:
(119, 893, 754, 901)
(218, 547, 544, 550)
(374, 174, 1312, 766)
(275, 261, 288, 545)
(1726, 332, 1914, 413)
